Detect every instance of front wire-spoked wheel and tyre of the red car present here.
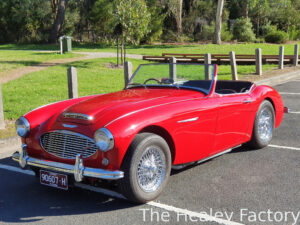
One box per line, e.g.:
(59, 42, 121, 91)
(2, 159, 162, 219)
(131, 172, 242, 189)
(119, 133, 171, 203)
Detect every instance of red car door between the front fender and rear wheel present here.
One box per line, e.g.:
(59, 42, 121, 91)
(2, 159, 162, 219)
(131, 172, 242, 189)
(211, 93, 253, 154)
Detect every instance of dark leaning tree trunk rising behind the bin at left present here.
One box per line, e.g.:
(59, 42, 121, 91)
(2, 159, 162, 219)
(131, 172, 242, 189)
(49, 0, 69, 43)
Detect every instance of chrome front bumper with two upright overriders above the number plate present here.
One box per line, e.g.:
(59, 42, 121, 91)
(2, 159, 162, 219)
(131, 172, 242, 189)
(12, 144, 124, 182)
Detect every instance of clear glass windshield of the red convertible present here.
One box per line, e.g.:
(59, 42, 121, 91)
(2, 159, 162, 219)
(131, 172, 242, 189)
(126, 63, 215, 94)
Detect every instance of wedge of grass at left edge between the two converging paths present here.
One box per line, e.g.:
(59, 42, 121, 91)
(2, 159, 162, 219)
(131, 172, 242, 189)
(0, 50, 78, 73)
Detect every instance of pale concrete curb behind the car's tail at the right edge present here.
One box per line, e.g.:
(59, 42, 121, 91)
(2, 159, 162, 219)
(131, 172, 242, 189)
(254, 70, 300, 86)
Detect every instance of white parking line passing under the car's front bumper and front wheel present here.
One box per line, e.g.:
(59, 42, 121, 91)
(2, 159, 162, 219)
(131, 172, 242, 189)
(0, 164, 243, 225)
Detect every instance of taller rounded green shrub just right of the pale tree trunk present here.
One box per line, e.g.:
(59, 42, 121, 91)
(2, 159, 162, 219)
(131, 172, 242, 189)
(233, 18, 255, 42)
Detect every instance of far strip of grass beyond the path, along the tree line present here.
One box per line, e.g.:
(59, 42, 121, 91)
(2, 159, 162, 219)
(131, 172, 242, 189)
(0, 43, 294, 55)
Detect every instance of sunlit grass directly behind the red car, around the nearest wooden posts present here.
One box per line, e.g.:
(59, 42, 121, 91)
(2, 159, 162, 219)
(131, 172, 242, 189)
(2, 58, 278, 120)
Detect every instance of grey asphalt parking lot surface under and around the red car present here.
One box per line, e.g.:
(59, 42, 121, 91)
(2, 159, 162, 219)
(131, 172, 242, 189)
(0, 79, 300, 225)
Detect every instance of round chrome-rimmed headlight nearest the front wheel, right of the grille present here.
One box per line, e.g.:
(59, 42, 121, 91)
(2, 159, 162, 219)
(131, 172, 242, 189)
(94, 128, 115, 152)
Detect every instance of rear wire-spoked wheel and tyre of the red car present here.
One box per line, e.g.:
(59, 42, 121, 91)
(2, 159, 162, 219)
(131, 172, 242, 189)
(247, 100, 275, 149)
